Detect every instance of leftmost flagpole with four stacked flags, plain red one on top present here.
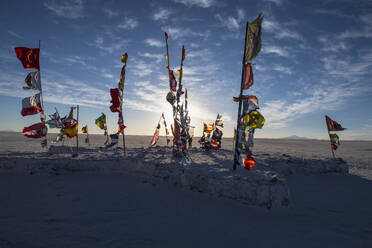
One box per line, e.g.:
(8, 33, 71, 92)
(14, 47, 48, 147)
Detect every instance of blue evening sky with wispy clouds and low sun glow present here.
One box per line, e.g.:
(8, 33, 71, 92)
(0, 0, 372, 140)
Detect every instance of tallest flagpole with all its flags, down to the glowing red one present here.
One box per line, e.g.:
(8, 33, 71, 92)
(233, 13, 265, 170)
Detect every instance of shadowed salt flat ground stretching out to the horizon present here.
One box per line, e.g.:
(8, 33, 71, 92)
(0, 133, 372, 247)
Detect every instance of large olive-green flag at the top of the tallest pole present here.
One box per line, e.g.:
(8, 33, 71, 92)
(244, 13, 263, 63)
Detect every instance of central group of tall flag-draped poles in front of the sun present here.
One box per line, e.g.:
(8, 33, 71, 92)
(163, 32, 194, 157)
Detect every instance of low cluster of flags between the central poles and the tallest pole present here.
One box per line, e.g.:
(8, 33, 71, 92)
(199, 114, 223, 149)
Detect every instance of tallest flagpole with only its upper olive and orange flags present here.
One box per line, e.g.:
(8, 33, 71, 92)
(233, 13, 263, 170)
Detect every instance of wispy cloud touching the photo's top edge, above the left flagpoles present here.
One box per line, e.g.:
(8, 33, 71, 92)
(44, 0, 84, 19)
